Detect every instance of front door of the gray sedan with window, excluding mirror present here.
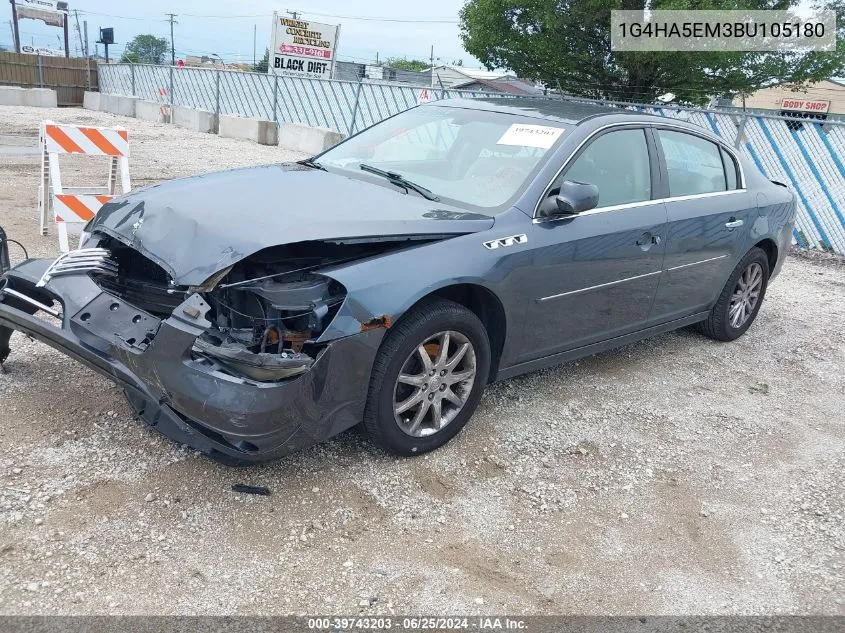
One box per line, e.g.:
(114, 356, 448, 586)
(520, 128, 666, 361)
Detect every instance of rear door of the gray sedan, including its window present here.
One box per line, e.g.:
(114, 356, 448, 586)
(650, 128, 757, 324)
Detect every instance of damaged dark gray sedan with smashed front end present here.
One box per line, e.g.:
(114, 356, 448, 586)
(0, 100, 795, 464)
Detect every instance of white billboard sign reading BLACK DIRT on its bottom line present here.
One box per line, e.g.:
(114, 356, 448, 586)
(267, 13, 340, 79)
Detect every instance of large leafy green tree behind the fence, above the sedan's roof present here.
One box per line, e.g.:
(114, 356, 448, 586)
(460, 0, 845, 104)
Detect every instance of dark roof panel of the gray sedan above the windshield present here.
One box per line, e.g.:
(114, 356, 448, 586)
(426, 97, 662, 125)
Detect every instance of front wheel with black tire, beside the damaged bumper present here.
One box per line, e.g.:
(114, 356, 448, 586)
(364, 299, 490, 456)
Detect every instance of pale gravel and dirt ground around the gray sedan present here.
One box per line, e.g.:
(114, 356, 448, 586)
(0, 107, 845, 614)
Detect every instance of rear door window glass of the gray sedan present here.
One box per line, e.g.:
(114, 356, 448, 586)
(657, 130, 736, 197)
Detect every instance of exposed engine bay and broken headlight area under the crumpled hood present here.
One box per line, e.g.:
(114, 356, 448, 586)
(91, 236, 431, 382)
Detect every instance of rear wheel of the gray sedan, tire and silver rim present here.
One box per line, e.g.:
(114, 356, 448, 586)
(696, 246, 770, 342)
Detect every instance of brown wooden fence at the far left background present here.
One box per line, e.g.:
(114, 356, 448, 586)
(0, 52, 97, 106)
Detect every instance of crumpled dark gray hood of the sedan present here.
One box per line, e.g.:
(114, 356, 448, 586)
(88, 164, 494, 285)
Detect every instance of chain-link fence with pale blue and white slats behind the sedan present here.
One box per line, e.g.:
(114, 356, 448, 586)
(94, 64, 845, 254)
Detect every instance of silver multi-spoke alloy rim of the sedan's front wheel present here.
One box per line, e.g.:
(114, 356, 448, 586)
(393, 330, 476, 437)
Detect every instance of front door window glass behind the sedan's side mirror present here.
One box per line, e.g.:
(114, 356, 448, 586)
(563, 129, 651, 208)
